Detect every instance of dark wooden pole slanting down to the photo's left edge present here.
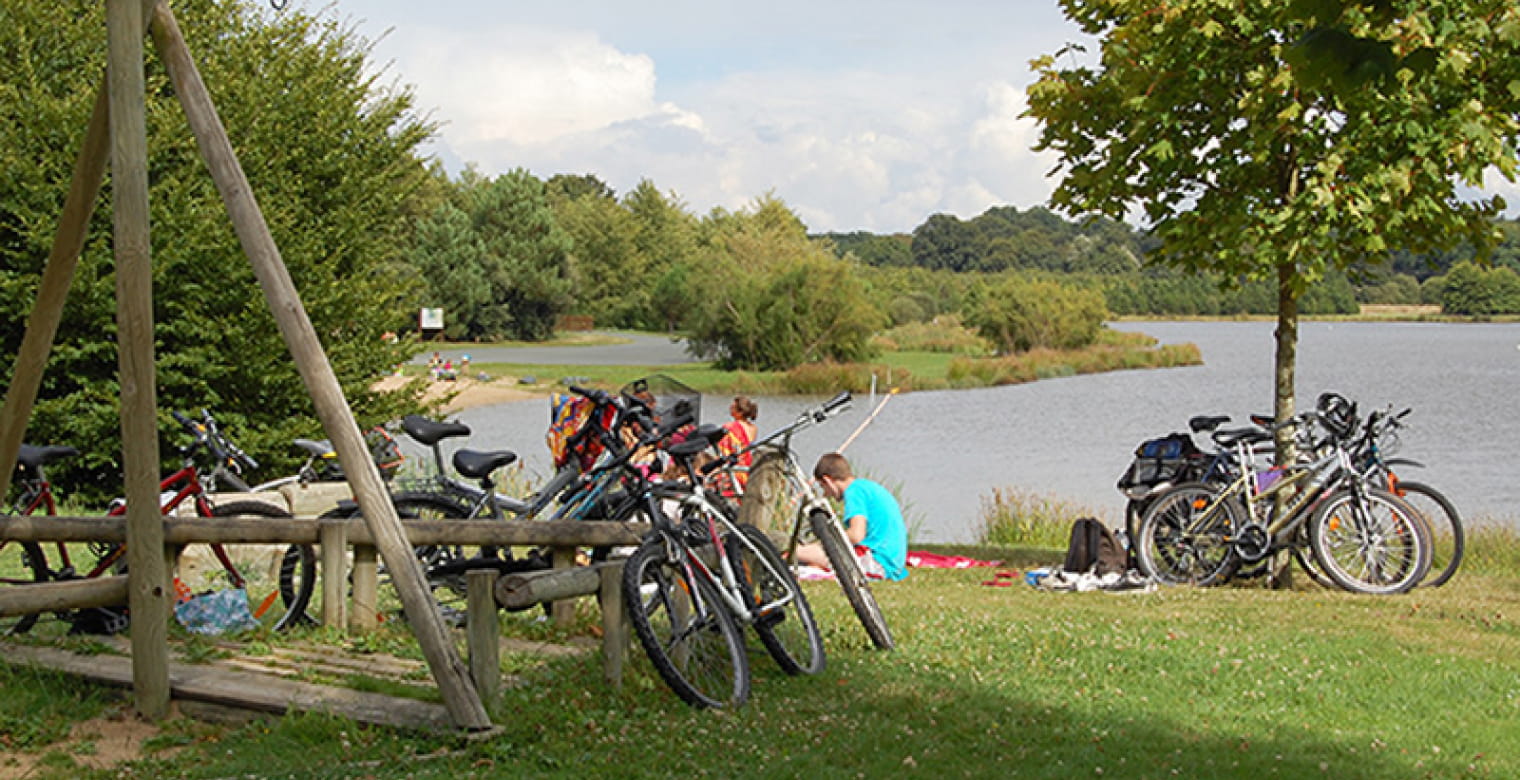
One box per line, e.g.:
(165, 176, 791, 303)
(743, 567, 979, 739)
(0, 84, 111, 496)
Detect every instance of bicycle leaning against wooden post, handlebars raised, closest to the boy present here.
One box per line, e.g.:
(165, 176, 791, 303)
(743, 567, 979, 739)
(708, 392, 894, 649)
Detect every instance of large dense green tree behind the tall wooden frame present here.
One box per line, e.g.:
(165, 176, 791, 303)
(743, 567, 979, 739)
(0, 0, 432, 499)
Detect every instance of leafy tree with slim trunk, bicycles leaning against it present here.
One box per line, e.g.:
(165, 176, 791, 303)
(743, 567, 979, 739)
(1029, 0, 1520, 450)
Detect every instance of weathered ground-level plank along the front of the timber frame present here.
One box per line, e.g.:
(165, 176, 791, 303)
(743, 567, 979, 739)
(0, 643, 450, 730)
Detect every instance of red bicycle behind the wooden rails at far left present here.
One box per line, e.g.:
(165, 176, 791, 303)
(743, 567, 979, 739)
(0, 412, 316, 633)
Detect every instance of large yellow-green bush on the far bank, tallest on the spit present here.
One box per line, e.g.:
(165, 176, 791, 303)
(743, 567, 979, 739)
(687, 198, 882, 371)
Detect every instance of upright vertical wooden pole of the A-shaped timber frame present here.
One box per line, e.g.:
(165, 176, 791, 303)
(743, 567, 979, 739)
(106, 0, 170, 719)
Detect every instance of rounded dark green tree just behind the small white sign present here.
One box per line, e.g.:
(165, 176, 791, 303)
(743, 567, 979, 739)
(413, 169, 572, 341)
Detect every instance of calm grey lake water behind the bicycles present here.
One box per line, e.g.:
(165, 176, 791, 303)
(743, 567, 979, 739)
(431, 322, 1520, 541)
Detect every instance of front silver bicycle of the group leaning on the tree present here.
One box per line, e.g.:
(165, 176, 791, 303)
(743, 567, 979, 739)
(1135, 407, 1430, 593)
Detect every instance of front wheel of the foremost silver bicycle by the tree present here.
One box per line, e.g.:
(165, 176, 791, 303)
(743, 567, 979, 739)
(1309, 488, 1430, 595)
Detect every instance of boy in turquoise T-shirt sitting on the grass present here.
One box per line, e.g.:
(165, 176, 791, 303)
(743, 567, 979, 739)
(796, 452, 907, 579)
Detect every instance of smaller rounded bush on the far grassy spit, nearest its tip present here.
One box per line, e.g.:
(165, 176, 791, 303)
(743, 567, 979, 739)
(965, 270, 1108, 353)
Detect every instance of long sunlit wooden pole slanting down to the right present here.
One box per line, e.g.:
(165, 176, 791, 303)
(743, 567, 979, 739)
(148, 0, 491, 730)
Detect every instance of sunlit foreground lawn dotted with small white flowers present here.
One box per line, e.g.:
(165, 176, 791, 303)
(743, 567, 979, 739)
(0, 549, 1520, 778)
